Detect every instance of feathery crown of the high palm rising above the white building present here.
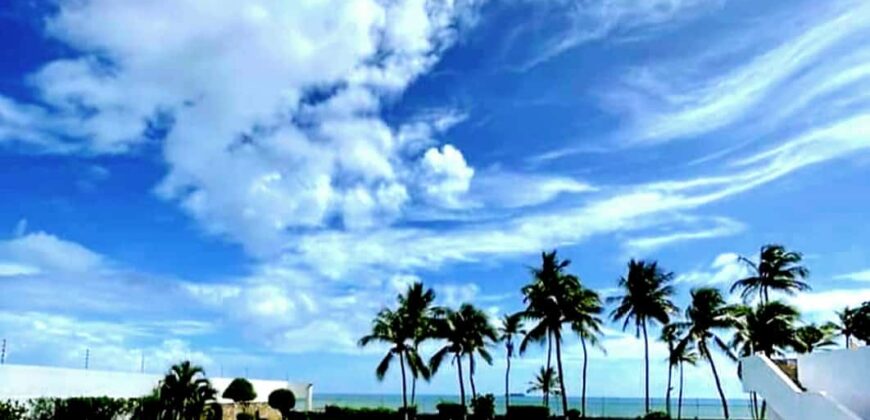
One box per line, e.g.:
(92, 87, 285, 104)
(731, 245, 810, 303)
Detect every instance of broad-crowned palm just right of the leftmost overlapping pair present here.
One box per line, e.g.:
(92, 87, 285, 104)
(429, 303, 497, 406)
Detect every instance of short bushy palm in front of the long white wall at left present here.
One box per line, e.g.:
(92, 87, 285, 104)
(158, 360, 217, 420)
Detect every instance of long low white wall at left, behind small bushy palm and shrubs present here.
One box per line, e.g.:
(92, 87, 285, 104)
(0, 365, 314, 411)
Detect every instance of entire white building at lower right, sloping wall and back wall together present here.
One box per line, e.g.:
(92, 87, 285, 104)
(741, 347, 870, 420)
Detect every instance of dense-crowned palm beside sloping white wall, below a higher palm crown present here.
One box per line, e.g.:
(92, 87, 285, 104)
(730, 301, 800, 418)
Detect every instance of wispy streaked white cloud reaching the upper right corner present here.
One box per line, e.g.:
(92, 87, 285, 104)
(605, 2, 870, 142)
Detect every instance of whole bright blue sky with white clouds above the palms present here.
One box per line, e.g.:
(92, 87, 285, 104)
(0, 0, 870, 397)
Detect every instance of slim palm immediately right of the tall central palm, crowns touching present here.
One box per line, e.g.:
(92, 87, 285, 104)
(567, 281, 606, 418)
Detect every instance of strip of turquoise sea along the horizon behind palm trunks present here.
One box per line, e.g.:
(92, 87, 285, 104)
(314, 393, 752, 419)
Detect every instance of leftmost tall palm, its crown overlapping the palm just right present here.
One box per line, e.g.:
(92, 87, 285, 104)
(359, 308, 429, 418)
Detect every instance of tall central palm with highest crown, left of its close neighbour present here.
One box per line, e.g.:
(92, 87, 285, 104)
(520, 251, 579, 416)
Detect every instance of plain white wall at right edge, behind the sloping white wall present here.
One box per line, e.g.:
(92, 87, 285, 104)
(798, 347, 870, 419)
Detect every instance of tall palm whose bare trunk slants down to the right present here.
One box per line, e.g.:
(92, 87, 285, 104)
(676, 287, 735, 420)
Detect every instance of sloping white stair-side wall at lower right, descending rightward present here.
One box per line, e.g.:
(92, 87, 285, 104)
(740, 355, 861, 420)
